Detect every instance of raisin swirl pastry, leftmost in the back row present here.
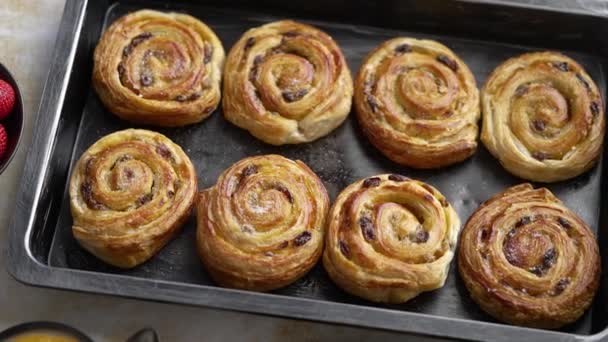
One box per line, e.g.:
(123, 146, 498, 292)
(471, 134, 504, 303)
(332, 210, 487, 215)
(93, 10, 224, 126)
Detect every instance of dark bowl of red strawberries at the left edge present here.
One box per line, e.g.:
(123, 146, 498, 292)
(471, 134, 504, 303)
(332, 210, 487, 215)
(0, 64, 23, 174)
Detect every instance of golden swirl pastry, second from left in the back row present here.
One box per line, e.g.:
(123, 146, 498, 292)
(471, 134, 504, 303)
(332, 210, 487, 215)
(223, 20, 353, 145)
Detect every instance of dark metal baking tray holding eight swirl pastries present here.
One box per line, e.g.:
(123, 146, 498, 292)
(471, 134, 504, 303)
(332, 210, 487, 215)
(8, 0, 608, 341)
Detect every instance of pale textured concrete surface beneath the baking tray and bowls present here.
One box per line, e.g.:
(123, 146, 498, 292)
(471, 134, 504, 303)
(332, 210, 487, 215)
(0, 0, 428, 342)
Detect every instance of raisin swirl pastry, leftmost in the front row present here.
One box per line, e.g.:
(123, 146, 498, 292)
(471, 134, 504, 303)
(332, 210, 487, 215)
(70, 129, 197, 268)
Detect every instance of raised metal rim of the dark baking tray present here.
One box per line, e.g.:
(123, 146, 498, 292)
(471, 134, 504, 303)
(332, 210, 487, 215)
(6, 0, 608, 342)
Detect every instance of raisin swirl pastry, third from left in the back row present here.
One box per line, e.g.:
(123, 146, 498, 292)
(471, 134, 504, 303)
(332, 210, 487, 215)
(355, 38, 479, 169)
